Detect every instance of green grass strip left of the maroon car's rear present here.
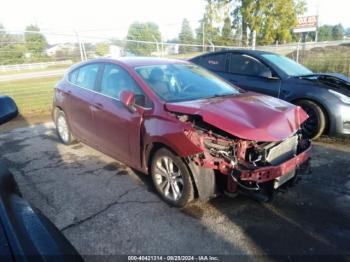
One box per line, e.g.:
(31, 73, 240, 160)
(0, 76, 61, 115)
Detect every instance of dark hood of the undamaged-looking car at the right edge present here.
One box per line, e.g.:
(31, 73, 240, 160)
(298, 73, 350, 96)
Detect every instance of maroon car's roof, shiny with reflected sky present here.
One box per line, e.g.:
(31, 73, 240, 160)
(84, 57, 188, 67)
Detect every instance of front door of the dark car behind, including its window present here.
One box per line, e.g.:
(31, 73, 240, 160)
(225, 53, 281, 97)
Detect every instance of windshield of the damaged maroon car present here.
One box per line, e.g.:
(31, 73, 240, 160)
(135, 64, 240, 102)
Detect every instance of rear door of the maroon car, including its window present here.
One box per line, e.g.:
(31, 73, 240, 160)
(64, 63, 100, 144)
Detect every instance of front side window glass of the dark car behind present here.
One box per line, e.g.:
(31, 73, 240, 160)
(230, 54, 270, 76)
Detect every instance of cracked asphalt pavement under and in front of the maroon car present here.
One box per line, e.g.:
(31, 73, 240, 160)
(0, 123, 350, 260)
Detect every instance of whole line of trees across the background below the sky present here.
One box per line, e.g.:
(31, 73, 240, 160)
(0, 0, 350, 64)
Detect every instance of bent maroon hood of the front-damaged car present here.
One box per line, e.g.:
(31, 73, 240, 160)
(165, 92, 308, 142)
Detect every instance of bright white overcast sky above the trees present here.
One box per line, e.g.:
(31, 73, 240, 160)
(0, 0, 350, 43)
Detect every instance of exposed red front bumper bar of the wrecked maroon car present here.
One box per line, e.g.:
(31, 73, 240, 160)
(227, 145, 311, 193)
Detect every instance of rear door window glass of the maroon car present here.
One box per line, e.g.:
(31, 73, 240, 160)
(69, 64, 100, 90)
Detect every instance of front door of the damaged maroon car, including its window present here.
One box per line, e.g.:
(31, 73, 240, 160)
(93, 63, 143, 166)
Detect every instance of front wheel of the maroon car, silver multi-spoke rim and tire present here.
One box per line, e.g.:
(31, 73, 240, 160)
(151, 148, 194, 207)
